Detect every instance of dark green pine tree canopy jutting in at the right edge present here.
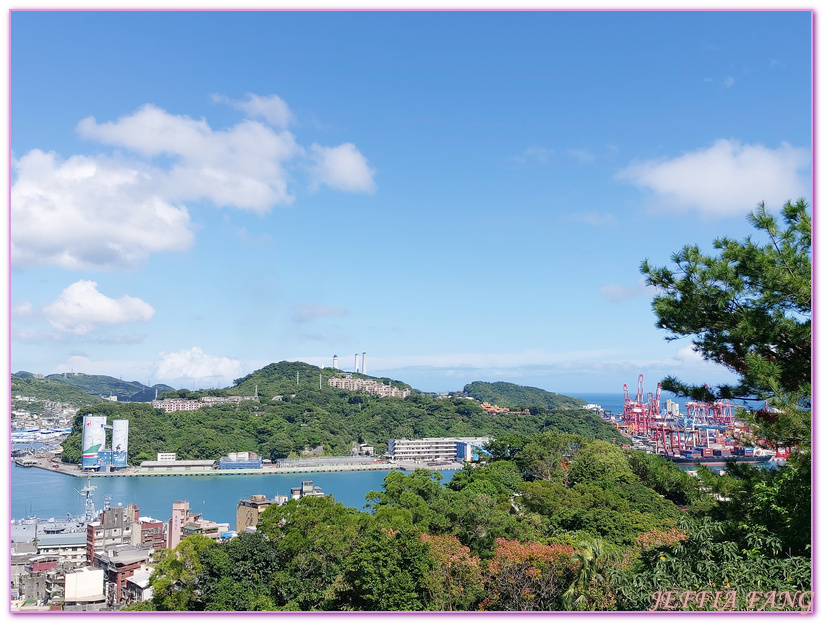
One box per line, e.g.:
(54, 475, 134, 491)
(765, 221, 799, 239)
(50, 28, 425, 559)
(640, 199, 812, 445)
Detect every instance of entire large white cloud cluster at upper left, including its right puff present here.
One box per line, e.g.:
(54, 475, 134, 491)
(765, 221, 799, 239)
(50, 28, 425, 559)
(11, 94, 375, 270)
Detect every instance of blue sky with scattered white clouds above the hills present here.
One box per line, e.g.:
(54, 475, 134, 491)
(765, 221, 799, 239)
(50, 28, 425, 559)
(10, 11, 812, 393)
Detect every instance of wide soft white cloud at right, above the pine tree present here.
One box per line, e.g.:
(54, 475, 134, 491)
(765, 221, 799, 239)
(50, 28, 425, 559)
(616, 140, 810, 217)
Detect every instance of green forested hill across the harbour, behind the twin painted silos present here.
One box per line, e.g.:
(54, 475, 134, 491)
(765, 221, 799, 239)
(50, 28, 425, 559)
(58, 362, 620, 464)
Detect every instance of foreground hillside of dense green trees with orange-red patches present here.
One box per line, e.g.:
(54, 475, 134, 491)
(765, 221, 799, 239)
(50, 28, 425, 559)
(128, 432, 811, 612)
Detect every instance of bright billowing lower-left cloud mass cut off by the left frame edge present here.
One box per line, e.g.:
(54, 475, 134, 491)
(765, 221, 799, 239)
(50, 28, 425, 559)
(11, 149, 194, 270)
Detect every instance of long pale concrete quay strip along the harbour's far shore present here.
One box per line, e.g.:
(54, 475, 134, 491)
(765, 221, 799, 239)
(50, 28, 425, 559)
(12, 459, 463, 478)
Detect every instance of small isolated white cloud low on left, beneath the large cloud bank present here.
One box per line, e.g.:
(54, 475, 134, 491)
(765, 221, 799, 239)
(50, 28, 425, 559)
(43, 280, 154, 335)
